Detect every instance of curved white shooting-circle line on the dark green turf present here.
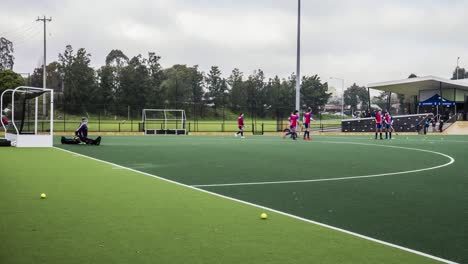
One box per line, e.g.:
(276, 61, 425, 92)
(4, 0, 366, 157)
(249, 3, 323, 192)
(192, 141, 455, 188)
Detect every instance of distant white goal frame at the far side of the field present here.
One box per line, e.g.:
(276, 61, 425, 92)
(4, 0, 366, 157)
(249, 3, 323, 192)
(141, 109, 187, 135)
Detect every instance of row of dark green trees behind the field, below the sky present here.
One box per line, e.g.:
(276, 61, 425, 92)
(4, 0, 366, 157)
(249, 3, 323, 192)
(22, 45, 331, 118)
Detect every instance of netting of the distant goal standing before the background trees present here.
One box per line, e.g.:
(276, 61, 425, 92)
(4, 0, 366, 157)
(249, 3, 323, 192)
(142, 109, 187, 135)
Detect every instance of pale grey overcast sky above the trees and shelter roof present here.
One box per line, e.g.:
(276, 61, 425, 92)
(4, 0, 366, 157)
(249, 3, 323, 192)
(0, 0, 468, 89)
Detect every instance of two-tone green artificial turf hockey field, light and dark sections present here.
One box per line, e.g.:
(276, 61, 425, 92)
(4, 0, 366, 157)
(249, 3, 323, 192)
(0, 136, 468, 263)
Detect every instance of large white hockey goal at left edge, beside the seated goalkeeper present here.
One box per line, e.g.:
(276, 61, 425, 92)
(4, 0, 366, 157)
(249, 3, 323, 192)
(0, 86, 54, 148)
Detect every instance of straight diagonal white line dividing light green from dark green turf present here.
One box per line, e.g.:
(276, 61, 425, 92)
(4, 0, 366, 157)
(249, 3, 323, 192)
(54, 147, 459, 264)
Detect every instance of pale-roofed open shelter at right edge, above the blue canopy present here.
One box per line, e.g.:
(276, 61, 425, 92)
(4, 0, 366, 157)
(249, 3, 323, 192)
(367, 76, 468, 119)
